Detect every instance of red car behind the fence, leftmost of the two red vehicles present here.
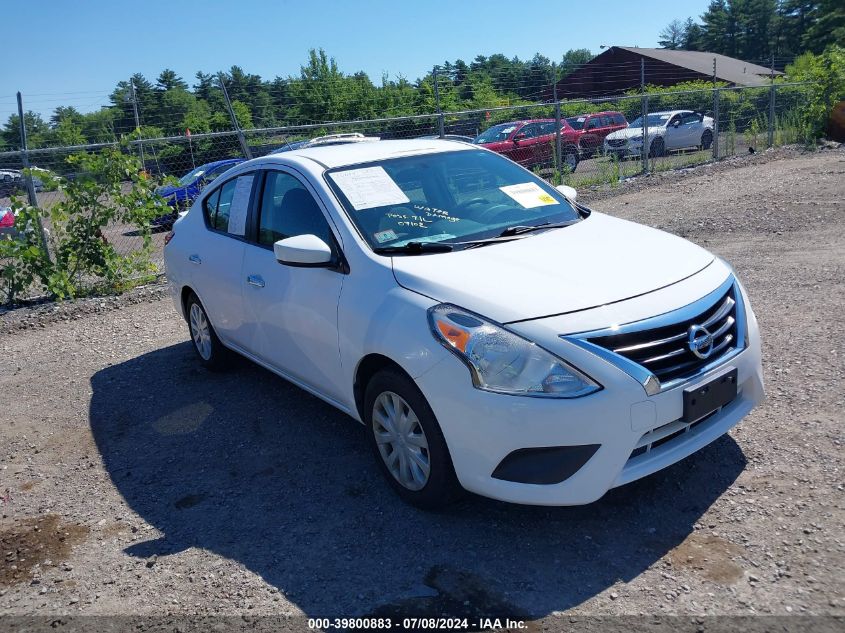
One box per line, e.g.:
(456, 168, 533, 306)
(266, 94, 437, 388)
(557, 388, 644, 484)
(473, 119, 580, 172)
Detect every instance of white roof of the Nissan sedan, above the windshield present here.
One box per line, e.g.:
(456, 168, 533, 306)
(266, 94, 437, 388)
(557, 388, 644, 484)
(263, 139, 478, 169)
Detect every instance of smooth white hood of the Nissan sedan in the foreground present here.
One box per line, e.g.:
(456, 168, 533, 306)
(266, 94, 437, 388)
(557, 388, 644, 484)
(393, 212, 714, 323)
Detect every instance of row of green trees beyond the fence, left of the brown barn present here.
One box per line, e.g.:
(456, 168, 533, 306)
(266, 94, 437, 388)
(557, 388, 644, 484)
(0, 49, 593, 151)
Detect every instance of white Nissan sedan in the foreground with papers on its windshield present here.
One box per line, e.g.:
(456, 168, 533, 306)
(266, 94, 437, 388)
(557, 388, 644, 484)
(165, 140, 763, 508)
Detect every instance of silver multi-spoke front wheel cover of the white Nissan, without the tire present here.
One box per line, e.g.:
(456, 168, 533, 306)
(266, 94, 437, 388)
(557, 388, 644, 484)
(373, 391, 431, 490)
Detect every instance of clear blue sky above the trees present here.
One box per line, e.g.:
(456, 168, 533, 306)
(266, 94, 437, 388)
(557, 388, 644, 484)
(0, 0, 707, 122)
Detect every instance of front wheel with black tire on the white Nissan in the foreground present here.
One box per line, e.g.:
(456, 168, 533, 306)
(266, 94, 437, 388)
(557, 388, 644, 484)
(364, 369, 462, 510)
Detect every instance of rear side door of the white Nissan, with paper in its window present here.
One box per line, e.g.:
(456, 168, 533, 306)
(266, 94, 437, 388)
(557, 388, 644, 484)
(187, 172, 255, 347)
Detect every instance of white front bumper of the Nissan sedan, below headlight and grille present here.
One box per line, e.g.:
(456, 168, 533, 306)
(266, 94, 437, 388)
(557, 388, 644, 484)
(417, 286, 764, 505)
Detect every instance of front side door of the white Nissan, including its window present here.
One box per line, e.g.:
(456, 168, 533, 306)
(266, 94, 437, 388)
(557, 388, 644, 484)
(241, 171, 344, 399)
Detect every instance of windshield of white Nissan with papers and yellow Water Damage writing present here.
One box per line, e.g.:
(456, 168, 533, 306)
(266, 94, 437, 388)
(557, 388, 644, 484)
(328, 150, 580, 248)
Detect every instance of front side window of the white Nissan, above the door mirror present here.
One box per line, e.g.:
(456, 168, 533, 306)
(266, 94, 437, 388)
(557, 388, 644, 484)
(258, 171, 334, 246)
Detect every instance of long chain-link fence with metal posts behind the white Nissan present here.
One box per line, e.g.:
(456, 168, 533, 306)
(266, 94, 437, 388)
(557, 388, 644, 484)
(0, 83, 807, 301)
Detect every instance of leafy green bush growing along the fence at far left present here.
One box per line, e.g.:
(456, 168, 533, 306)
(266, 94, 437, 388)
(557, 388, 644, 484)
(0, 147, 164, 303)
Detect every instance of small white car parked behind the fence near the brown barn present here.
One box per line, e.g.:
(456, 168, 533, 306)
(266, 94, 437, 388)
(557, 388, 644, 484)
(604, 110, 713, 158)
